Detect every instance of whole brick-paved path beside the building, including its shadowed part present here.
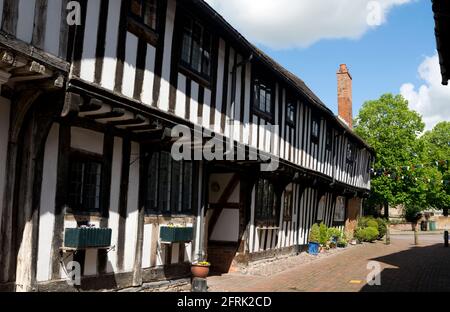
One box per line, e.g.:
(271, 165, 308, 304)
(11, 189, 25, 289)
(208, 235, 450, 292)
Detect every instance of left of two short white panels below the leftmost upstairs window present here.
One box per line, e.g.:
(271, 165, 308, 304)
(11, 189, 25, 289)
(122, 32, 138, 97)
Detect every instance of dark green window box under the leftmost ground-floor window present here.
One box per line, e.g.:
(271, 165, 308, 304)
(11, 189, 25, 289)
(64, 228, 112, 249)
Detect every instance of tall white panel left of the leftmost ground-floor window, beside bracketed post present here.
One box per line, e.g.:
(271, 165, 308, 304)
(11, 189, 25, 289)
(36, 123, 59, 282)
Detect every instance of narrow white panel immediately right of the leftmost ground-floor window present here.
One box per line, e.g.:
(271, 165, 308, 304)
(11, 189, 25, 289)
(106, 137, 123, 273)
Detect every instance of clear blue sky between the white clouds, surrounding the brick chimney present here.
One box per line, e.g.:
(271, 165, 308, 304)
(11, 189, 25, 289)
(259, 0, 436, 116)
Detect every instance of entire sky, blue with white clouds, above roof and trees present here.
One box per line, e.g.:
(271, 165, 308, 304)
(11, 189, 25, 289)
(206, 0, 450, 130)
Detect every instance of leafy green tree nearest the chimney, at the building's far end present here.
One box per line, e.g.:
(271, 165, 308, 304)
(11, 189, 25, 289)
(355, 94, 427, 214)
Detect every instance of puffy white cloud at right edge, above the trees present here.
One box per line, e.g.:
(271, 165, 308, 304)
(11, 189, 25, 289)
(400, 54, 450, 130)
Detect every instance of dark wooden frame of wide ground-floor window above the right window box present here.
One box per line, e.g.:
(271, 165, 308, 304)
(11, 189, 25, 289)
(143, 149, 196, 216)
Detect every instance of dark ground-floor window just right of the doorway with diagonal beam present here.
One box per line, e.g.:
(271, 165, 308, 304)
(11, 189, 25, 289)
(255, 179, 278, 225)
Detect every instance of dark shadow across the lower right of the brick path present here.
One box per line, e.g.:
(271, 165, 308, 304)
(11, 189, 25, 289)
(361, 244, 450, 292)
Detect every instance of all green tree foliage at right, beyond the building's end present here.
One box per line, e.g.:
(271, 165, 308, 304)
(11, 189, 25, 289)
(355, 94, 450, 214)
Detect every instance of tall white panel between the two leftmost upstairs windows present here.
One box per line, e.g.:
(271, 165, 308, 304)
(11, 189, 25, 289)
(158, 0, 177, 111)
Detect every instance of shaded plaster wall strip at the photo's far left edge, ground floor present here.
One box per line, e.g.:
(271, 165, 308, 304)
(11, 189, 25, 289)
(0, 97, 10, 235)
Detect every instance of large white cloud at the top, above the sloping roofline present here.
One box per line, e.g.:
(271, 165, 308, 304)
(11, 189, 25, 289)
(206, 0, 412, 49)
